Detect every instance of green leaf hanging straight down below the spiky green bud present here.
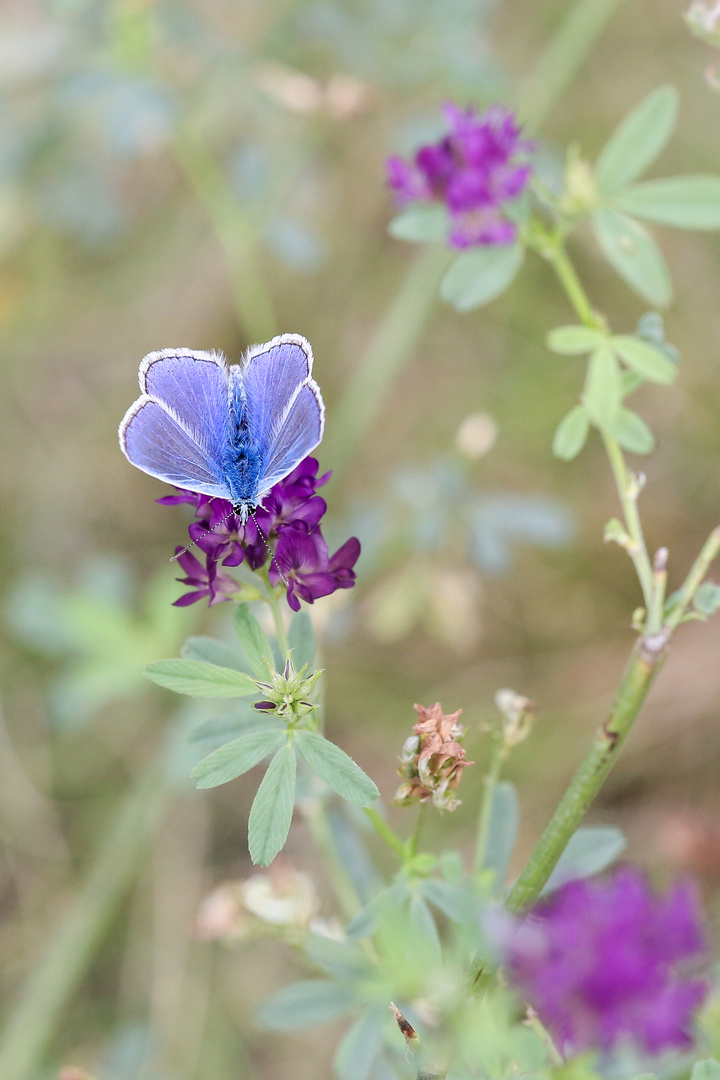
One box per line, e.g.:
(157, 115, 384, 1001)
(249, 743, 297, 866)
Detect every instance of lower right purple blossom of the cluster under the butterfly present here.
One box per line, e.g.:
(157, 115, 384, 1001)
(270, 524, 361, 611)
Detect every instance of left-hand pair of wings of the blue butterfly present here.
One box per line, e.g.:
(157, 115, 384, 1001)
(119, 349, 230, 499)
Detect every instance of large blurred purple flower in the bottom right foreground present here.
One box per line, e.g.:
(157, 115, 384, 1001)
(506, 867, 707, 1053)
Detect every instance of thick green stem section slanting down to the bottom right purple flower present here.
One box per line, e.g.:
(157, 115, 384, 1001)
(506, 638, 665, 912)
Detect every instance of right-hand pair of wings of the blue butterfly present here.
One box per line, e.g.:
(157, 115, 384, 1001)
(240, 334, 325, 499)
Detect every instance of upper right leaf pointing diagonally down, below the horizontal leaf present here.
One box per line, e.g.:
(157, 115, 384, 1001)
(593, 210, 673, 308)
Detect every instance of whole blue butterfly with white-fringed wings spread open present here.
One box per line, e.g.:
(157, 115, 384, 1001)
(119, 334, 325, 523)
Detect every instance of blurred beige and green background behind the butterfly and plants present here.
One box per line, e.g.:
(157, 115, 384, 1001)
(0, 0, 720, 1080)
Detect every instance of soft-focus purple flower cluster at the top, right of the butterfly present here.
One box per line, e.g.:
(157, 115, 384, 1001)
(386, 103, 532, 248)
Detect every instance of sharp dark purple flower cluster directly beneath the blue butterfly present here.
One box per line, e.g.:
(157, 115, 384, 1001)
(158, 458, 361, 611)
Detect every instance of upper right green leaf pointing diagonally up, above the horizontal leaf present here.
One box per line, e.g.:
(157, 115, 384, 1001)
(595, 86, 678, 195)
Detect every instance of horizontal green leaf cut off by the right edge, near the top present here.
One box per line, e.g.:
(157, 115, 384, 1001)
(616, 176, 720, 229)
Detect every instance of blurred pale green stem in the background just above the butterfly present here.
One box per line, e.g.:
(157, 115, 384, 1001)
(173, 127, 279, 341)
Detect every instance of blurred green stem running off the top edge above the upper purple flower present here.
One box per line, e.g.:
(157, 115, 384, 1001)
(518, 0, 623, 131)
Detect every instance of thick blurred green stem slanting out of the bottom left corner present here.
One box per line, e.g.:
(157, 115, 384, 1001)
(0, 767, 167, 1080)
